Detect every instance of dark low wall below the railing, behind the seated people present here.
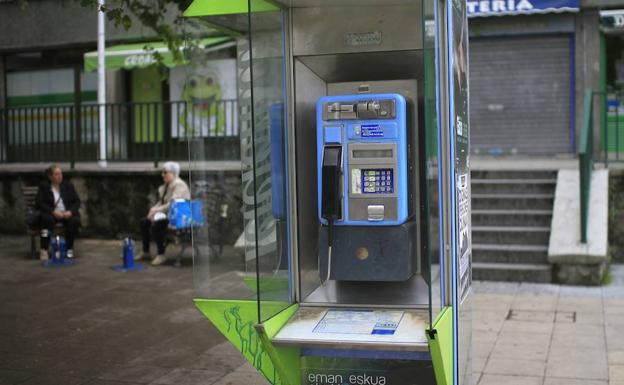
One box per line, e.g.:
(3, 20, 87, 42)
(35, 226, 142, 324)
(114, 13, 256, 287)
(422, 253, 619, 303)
(0, 171, 243, 244)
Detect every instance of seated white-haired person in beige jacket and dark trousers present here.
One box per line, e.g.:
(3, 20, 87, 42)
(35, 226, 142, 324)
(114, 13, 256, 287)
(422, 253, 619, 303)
(141, 162, 191, 266)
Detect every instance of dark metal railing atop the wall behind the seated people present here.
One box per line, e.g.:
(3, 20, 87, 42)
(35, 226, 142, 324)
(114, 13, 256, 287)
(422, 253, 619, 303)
(0, 100, 240, 165)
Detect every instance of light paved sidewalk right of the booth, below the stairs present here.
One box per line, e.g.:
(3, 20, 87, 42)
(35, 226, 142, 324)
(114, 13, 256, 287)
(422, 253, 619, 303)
(473, 265, 624, 385)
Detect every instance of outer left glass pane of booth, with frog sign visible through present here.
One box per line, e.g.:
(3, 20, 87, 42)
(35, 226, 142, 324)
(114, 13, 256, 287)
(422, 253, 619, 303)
(186, 13, 257, 308)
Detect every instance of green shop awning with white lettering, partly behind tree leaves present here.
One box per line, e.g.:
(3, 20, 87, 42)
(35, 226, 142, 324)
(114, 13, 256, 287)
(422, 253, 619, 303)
(84, 36, 236, 72)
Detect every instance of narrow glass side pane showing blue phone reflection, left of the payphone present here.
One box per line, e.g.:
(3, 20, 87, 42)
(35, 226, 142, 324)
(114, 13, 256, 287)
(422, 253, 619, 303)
(246, 0, 293, 321)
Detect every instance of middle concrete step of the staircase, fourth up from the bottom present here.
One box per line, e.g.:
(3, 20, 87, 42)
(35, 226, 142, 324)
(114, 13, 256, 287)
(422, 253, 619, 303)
(472, 210, 552, 226)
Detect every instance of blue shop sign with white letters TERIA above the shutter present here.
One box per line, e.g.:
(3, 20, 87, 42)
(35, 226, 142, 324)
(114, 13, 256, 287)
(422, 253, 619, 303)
(466, 0, 580, 17)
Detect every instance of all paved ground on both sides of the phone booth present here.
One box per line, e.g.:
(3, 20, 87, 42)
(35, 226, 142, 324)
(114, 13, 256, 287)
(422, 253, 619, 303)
(0, 236, 624, 385)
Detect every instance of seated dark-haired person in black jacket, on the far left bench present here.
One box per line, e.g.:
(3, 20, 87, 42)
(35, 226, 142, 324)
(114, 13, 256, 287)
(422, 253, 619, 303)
(35, 165, 80, 260)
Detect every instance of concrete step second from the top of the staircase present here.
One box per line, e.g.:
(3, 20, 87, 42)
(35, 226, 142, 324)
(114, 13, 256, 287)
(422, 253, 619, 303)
(470, 178, 557, 194)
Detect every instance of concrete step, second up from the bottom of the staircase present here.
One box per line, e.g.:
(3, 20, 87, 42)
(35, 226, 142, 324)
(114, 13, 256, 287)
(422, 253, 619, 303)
(472, 244, 548, 264)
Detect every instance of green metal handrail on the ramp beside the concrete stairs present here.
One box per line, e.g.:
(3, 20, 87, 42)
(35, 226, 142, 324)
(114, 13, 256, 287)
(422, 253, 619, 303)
(578, 90, 596, 243)
